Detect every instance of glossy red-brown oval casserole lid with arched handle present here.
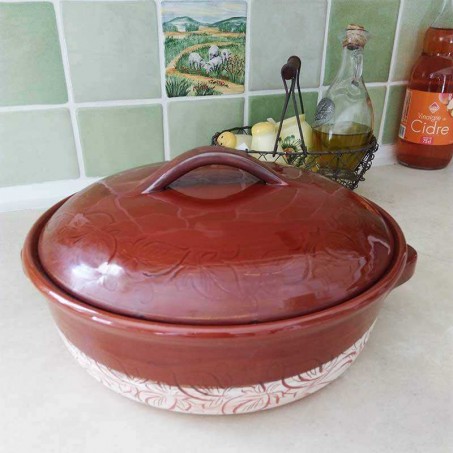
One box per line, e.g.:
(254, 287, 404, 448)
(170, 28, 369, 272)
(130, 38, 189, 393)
(38, 146, 393, 325)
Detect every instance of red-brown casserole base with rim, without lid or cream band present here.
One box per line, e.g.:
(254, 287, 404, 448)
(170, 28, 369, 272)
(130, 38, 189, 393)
(22, 194, 416, 387)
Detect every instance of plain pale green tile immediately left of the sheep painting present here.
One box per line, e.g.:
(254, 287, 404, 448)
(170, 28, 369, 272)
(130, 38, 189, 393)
(62, 1, 161, 102)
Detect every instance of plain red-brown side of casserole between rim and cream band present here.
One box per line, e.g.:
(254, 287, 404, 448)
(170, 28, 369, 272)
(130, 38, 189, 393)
(50, 299, 382, 388)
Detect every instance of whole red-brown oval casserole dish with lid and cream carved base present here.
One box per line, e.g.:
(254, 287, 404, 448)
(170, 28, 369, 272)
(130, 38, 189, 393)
(22, 147, 417, 414)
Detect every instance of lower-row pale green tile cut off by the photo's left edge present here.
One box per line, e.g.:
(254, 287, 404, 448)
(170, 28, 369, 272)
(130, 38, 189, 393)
(0, 109, 79, 187)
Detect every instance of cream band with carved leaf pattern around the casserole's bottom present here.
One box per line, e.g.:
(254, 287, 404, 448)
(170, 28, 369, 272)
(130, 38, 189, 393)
(60, 324, 374, 415)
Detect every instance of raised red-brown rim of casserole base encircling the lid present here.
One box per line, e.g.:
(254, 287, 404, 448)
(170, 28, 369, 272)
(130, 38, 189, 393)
(22, 199, 407, 338)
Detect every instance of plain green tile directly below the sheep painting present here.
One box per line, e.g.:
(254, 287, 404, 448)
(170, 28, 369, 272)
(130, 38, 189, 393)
(168, 98, 244, 157)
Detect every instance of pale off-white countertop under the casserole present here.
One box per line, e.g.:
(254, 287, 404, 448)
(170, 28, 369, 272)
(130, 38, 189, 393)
(0, 165, 453, 453)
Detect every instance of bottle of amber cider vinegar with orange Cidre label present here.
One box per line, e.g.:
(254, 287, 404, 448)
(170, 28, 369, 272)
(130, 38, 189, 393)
(396, 0, 453, 170)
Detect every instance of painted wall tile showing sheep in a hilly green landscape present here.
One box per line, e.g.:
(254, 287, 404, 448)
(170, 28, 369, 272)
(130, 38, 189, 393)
(162, 0, 247, 97)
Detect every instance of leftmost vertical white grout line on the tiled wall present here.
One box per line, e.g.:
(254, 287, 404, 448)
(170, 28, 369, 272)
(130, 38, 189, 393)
(52, 0, 86, 178)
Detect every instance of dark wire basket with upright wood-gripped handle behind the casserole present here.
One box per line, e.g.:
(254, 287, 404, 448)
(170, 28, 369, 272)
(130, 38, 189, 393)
(212, 56, 379, 190)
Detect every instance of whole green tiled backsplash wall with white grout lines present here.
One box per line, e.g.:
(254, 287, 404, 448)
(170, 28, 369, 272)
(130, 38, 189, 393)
(0, 0, 442, 187)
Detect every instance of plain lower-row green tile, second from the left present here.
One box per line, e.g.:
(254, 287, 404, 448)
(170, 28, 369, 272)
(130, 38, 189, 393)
(78, 105, 164, 176)
